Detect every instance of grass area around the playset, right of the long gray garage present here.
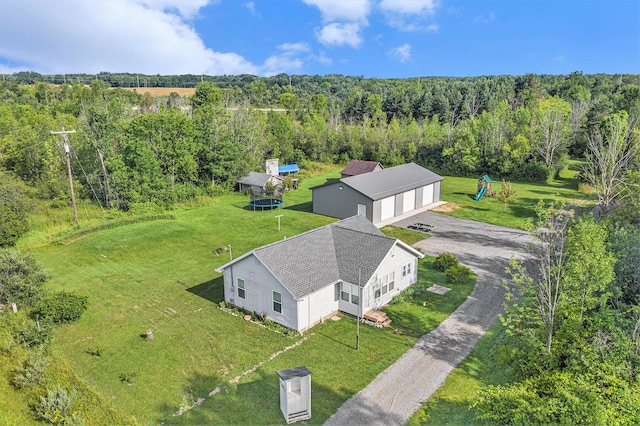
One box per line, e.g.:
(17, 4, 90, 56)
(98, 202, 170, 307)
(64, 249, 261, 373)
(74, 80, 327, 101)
(440, 160, 595, 229)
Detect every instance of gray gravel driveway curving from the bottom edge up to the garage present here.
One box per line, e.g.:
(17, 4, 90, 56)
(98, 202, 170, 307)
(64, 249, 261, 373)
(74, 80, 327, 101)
(325, 212, 531, 425)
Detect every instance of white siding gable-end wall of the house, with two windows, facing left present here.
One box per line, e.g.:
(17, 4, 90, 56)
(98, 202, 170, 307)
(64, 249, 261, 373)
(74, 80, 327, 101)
(224, 255, 298, 330)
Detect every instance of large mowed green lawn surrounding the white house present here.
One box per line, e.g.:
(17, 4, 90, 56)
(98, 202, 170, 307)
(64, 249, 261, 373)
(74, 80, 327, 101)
(23, 162, 596, 424)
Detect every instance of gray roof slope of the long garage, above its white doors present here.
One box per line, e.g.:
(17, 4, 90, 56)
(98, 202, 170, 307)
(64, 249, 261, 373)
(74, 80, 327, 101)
(340, 163, 442, 201)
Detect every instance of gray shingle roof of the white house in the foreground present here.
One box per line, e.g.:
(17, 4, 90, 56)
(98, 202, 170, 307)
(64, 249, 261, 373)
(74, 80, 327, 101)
(253, 216, 396, 298)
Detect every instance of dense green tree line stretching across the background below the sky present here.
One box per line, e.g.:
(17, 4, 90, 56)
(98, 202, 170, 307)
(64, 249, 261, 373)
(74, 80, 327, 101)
(0, 73, 640, 243)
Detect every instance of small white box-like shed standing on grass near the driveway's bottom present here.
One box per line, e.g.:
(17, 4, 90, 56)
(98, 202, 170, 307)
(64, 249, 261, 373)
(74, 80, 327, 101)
(276, 366, 311, 424)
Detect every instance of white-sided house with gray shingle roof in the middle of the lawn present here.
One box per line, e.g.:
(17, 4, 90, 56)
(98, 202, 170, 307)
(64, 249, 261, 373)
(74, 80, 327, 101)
(216, 216, 424, 332)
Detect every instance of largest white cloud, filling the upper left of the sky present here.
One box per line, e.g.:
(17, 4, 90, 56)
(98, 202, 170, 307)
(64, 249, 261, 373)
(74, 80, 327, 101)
(0, 0, 258, 75)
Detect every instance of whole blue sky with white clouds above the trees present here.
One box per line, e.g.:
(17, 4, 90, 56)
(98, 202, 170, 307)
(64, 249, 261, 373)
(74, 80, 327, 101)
(0, 0, 640, 78)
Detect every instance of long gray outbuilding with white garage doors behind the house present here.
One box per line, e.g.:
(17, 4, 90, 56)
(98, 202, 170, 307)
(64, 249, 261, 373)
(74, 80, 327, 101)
(311, 163, 443, 226)
